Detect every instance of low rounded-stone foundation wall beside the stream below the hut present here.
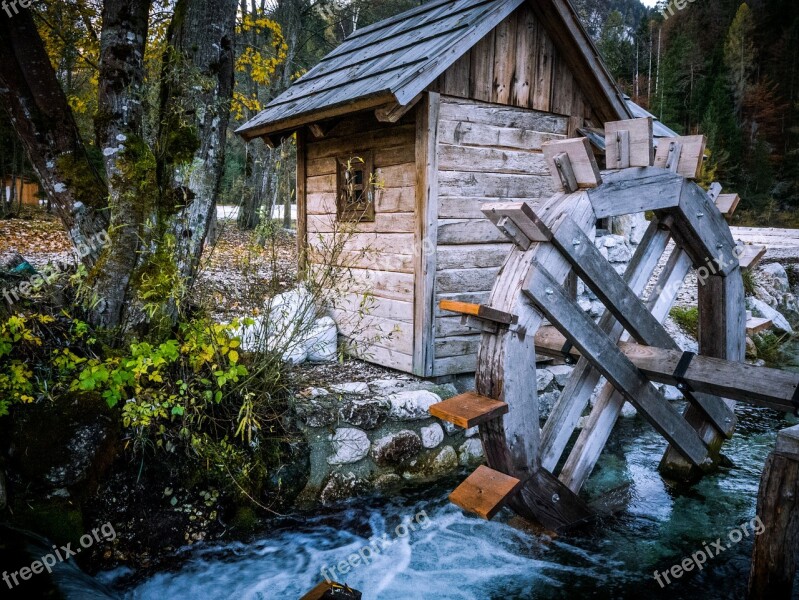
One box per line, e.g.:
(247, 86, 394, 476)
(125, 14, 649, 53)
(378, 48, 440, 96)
(294, 379, 483, 504)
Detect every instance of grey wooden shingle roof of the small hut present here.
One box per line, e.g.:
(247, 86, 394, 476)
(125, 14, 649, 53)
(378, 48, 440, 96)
(237, 0, 626, 139)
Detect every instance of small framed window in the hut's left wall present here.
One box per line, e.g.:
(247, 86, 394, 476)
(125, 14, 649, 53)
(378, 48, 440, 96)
(336, 152, 375, 223)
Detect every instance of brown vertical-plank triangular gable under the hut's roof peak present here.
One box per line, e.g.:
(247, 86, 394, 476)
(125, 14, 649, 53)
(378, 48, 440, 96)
(431, 3, 601, 134)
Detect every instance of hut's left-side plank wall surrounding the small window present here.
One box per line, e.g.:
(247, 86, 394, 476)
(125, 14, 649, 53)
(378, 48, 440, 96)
(305, 111, 416, 372)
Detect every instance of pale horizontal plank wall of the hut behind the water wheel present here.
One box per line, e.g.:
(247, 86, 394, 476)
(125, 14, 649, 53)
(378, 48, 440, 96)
(433, 96, 569, 375)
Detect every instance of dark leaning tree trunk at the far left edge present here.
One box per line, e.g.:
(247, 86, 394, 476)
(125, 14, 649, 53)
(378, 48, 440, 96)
(0, 10, 108, 260)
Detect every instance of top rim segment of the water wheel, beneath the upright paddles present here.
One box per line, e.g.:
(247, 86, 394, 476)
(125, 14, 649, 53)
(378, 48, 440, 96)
(588, 167, 685, 219)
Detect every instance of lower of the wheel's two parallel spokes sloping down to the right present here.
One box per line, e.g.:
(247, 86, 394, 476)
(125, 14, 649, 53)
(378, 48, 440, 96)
(524, 264, 712, 468)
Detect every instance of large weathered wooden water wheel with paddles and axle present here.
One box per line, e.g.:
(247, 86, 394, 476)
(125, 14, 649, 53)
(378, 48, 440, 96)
(430, 119, 797, 530)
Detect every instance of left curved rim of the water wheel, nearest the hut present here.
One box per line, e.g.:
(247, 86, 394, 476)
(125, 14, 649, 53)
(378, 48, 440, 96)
(475, 192, 596, 530)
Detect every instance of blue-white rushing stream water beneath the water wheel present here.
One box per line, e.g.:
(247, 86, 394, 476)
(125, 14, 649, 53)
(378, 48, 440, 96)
(95, 400, 799, 600)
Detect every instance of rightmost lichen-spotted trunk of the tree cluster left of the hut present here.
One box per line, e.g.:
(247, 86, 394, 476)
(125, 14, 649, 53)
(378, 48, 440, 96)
(159, 0, 237, 284)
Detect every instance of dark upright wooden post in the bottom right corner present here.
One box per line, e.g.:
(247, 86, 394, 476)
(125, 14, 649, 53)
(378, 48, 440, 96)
(748, 425, 799, 600)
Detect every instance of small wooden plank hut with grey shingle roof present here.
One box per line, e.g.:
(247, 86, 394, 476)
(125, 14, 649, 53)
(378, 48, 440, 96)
(238, 0, 648, 378)
